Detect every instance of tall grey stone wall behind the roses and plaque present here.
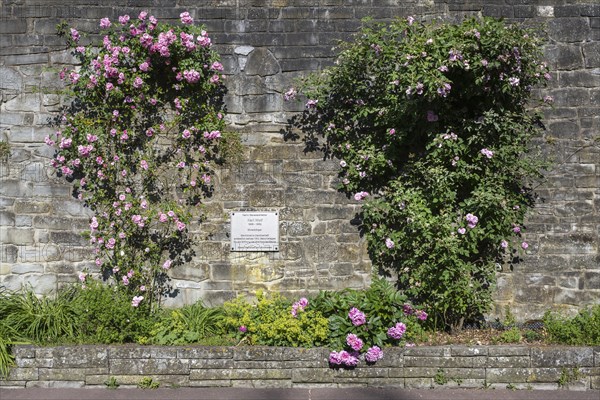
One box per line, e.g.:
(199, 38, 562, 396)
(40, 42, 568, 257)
(0, 0, 600, 319)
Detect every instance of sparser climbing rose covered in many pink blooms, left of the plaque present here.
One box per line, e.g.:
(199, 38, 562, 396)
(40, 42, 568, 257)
(51, 12, 238, 307)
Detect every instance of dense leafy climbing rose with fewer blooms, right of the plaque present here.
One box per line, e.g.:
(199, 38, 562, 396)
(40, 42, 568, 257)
(292, 18, 551, 329)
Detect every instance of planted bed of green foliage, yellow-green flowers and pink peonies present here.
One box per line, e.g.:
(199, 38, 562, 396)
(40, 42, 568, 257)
(0, 280, 600, 377)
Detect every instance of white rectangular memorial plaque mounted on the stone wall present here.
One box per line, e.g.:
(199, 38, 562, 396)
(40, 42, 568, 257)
(230, 211, 279, 251)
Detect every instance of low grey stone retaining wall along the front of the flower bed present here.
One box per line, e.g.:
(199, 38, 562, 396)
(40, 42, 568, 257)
(0, 346, 600, 390)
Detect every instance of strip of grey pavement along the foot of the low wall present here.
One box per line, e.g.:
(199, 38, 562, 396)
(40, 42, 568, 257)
(0, 388, 600, 400)
